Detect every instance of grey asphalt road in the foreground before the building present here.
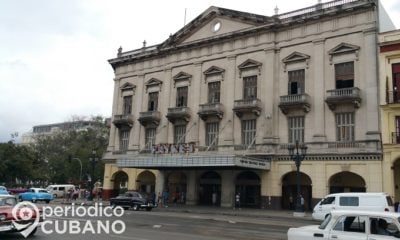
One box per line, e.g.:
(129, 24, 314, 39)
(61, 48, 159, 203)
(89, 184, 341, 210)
(0, 209, 315, 240)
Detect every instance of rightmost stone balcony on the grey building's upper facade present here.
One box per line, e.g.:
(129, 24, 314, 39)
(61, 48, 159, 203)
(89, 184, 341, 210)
(325, 87, 361, 110)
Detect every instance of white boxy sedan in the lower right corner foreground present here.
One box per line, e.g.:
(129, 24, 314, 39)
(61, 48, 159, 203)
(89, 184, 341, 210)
(288, 210, 400, 240)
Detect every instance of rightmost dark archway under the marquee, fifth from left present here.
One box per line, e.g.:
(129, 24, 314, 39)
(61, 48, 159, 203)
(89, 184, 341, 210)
(235, 171, 261, 207)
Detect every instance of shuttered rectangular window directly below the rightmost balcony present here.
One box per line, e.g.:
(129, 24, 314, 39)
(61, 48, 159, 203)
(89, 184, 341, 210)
(336, 113, 355, 142)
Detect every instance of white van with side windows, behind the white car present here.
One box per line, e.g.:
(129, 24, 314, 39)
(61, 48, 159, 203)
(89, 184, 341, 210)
(312, 192, 394, 220)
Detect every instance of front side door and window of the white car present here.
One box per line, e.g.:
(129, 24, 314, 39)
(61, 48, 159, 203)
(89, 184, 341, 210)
(329, 215, 368, 240)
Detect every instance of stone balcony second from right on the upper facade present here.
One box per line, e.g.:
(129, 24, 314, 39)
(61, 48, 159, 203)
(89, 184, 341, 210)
(279, 93, 311, 114)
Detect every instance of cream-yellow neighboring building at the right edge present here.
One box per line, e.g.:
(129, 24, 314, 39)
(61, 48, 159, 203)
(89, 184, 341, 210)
(379, 30, 400, 202)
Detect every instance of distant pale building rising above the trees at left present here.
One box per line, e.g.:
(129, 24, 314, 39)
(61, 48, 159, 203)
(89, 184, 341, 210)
(21, 120, 98, 144)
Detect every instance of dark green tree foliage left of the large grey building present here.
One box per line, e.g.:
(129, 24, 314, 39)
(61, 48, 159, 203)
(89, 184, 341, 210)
(0, 116, 109, 186)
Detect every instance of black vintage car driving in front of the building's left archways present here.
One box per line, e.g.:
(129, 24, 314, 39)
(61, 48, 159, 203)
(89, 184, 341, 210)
(110, 192, 154, 211)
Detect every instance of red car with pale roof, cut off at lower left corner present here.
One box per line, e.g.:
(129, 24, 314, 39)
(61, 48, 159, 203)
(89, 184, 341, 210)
(0, 195, 43, 237)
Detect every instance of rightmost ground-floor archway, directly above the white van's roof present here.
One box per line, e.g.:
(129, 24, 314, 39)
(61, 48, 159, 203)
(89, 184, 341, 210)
(329, 172, 366, 193)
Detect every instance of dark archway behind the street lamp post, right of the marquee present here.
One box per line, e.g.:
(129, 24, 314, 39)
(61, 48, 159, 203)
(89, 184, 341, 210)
(282, 172, 313, 211)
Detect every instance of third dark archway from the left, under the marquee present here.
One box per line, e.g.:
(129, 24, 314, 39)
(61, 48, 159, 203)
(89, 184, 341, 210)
(167, 172, 187, 203)
